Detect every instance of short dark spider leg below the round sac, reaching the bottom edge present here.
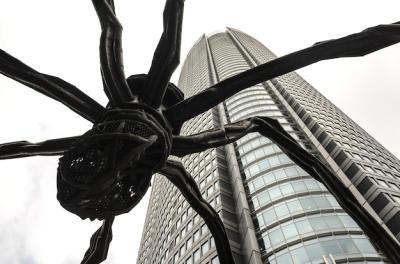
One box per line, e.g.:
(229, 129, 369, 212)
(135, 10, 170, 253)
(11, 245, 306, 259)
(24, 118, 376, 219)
(81, 217, 114, 264)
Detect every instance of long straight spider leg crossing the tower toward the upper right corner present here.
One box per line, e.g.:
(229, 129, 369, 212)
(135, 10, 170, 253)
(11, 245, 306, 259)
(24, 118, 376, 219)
(165, 22, 400, 124)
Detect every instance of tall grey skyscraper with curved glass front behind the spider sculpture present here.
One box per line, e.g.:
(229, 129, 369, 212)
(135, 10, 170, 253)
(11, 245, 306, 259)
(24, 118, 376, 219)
(137, 29, 400, 264)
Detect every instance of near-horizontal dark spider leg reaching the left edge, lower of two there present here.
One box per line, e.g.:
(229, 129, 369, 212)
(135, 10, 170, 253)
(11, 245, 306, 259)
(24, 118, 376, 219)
(0, 136, 81, 160)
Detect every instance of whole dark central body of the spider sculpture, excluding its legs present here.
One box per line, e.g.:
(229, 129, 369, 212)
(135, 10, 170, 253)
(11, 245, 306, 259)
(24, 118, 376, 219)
(57, 74, 183, 220)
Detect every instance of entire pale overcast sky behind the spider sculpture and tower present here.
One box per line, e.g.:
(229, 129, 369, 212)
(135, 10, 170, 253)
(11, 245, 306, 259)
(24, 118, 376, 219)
(0, 0, 400, 264)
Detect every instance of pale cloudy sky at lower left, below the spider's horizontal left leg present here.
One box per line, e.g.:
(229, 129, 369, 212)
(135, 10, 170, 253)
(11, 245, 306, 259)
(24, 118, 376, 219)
(0, 154, 150, 264)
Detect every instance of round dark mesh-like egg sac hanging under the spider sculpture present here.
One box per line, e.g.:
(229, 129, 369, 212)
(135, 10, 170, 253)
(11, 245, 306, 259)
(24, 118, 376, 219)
(57, 115, 170, 219)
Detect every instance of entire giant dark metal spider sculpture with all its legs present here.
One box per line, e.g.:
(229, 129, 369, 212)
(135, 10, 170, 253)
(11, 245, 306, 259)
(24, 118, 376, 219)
(0, 0, 400, 264)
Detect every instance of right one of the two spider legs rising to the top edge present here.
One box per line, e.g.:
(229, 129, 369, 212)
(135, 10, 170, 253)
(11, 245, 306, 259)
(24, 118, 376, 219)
(142, 0, 184, 107)
